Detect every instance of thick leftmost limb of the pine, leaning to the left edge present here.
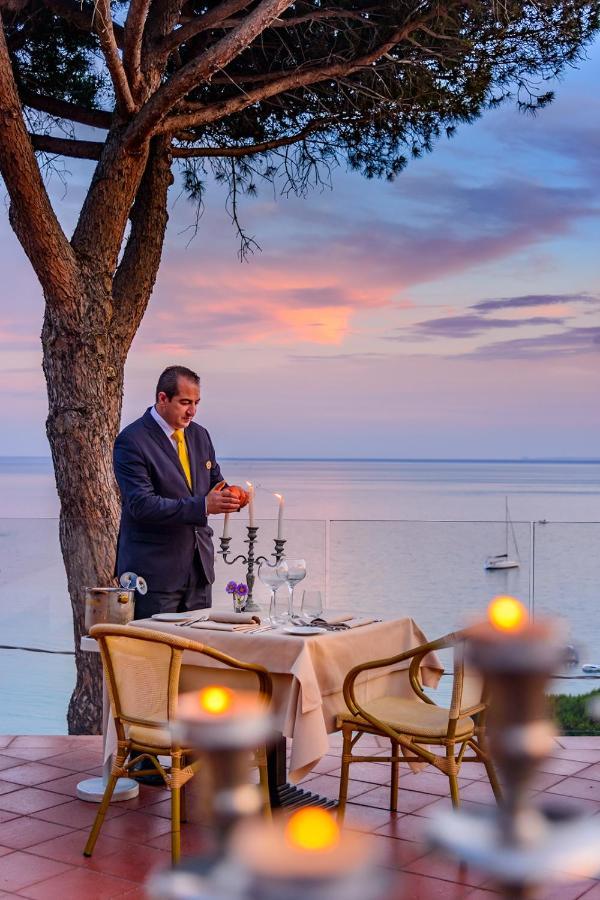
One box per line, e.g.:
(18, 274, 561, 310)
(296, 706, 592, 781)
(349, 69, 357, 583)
(0, 17, 79, 306)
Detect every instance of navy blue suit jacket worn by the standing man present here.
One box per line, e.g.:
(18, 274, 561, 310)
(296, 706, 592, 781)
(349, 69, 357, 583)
(113, 409, 223, 591)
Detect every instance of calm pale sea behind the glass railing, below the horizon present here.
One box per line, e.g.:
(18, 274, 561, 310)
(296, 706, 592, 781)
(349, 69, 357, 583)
(0, 458, 600, 734)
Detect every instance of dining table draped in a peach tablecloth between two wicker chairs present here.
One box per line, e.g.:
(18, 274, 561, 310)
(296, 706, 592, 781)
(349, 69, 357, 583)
(105, 617, 443, 807)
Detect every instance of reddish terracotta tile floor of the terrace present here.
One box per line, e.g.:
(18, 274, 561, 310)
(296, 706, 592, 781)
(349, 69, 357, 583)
(0, 735, 600, 900)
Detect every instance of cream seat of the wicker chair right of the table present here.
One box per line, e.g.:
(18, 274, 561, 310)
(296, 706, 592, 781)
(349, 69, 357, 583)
(338, 697, 475, 738)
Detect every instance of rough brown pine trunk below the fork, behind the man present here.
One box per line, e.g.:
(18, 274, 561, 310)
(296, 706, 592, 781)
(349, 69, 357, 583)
(42, 280, 126, 734)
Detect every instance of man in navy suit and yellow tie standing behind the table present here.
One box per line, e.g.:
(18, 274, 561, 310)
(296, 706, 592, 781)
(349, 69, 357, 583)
(113, 366, 245, 619)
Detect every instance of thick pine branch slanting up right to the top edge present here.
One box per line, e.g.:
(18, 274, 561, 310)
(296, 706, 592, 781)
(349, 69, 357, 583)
(125, 0, 293, 148)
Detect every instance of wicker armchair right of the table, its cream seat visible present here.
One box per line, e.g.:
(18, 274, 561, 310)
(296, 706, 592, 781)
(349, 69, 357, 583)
(336, 631, 501, 821)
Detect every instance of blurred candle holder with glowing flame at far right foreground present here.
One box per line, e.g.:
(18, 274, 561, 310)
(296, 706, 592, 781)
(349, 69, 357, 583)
(429, 597, 600, 900)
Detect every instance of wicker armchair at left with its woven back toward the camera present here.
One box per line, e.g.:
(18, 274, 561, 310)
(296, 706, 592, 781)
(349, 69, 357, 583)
(83, 625, 272, 863)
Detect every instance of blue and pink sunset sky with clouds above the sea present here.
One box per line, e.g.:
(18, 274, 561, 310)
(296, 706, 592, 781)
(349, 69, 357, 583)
(0, 37, 600, 458)
